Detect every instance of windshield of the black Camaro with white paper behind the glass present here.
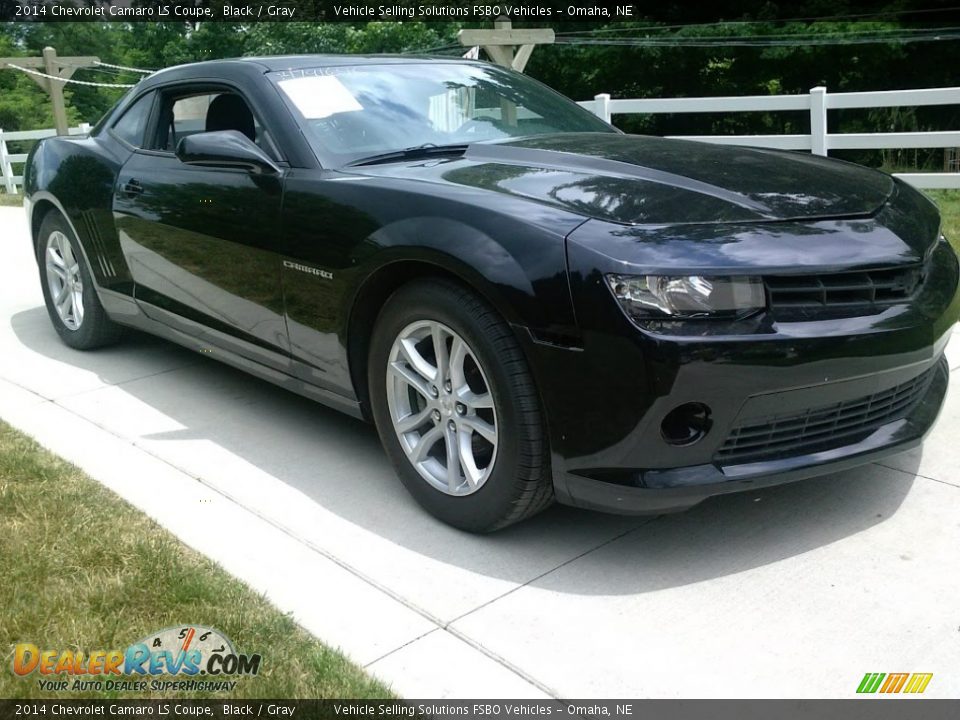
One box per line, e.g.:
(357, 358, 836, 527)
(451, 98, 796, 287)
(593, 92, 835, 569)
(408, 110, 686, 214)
(269, 62, 616, 165)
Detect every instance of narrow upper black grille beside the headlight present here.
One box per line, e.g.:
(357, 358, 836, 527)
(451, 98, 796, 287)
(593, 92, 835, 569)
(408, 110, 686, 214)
(763, 265, 923, 310)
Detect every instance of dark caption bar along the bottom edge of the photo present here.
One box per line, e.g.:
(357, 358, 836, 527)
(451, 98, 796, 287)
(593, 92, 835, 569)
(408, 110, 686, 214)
(0, 696, 960, 720)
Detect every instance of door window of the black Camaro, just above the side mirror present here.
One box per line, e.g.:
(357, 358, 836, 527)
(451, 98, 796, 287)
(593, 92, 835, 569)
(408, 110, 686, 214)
(158, 92, 274, 155)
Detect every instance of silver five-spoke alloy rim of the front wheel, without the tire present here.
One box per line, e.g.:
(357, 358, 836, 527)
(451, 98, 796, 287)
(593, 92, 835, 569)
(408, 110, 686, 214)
(387, 320, 499, 496)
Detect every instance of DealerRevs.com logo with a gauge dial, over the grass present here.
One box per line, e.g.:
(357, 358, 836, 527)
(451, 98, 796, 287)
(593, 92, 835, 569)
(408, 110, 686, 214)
(13, 625, 261, 692)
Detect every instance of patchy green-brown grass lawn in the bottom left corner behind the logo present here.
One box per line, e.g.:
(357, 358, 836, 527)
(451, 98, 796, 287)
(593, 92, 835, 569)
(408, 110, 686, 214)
(0, 422, 390, 699)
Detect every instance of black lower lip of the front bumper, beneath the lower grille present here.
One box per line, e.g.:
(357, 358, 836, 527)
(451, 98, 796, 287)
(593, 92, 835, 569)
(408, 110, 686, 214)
(554, 356, 949, 515)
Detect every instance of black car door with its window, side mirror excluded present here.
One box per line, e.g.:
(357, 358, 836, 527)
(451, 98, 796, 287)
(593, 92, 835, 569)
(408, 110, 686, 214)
(113, 85, 290, 371)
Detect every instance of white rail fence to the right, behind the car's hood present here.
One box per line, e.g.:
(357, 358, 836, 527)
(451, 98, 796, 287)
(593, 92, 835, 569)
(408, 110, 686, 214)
(580, 87, 960, 188)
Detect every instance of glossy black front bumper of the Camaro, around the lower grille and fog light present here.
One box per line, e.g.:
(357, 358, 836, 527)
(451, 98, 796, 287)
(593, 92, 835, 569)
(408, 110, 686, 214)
(524, 214, 960, 514)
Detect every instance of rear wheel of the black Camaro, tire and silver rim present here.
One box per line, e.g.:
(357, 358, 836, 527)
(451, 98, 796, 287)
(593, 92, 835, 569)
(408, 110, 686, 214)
(35, 211, 121, 350)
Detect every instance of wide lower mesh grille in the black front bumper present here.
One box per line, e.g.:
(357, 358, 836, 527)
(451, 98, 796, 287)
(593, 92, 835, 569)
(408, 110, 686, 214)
(715, 366, 936, 465)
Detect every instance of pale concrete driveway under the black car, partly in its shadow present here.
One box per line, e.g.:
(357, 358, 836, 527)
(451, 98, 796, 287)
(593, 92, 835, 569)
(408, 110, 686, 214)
(0, 208, 960, 698)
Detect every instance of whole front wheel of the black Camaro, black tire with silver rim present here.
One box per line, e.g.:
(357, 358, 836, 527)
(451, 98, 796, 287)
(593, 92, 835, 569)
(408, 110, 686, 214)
(368, 279, 553, 533)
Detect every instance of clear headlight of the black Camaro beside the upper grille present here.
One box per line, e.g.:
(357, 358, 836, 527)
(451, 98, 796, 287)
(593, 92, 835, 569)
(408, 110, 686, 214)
(607, 275, 767, 320)
